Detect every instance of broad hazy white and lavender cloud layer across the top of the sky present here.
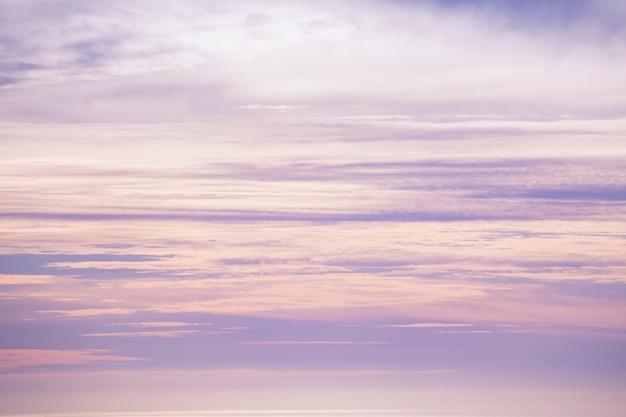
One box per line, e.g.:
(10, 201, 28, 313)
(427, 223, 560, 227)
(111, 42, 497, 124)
(0, 1, 626, 121)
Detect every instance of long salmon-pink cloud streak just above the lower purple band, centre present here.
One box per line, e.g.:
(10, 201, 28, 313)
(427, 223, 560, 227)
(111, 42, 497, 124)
(124, 274, 484, 315)
